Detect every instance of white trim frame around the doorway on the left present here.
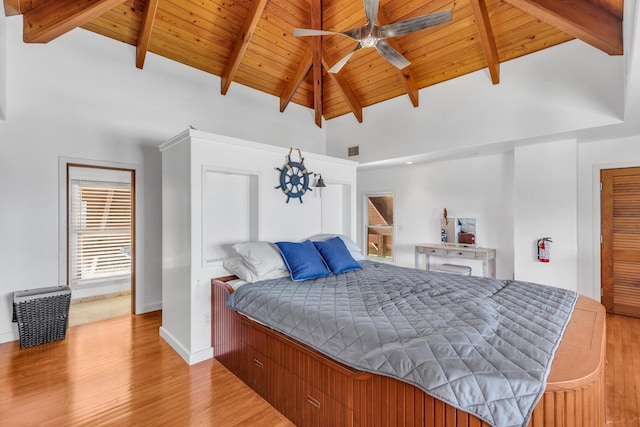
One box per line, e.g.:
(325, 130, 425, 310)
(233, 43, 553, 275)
(58, 157, 147, 314)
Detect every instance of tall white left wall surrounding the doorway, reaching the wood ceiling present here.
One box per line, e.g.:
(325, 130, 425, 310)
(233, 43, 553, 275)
(0, 16, 325, 342)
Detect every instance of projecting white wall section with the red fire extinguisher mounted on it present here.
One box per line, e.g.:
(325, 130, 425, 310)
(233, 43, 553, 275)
(513, 140, 578, 291)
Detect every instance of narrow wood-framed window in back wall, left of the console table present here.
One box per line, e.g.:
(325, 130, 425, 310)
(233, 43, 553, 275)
(366, 194, 393, 259)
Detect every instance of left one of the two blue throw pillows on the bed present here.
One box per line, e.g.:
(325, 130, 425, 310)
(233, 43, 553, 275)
(276, 240, 331, 281)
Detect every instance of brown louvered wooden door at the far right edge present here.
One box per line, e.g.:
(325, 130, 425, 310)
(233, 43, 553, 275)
(600, 168, 640, 317)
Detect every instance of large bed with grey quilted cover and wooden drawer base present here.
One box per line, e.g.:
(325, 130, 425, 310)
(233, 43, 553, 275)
(212, 239, 604, 426)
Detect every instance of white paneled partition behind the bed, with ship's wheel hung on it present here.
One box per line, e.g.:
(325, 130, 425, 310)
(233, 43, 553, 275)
(160, 129, 357, 364)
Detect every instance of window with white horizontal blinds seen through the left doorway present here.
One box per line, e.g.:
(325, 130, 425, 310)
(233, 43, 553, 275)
(68, 168, 133, 289)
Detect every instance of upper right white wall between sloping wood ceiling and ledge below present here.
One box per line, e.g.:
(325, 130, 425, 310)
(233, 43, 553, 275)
(327, 41, 625, 163)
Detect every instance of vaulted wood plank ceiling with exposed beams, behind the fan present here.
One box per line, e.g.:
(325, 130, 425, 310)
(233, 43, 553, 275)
(4, 0, 623, 126)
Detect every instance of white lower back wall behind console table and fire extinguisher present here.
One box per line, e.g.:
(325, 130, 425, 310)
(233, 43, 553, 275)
(358, 135, 640, 301)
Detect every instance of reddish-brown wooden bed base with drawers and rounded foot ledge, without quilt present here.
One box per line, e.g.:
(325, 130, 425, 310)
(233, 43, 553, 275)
(211, 276, 606, 427)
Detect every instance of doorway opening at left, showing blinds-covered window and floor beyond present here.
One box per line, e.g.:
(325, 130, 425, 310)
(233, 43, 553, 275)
(66, 164, 136, 325)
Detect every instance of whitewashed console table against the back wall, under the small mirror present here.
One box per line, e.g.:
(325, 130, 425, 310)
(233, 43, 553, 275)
(416, 243, 496, 279)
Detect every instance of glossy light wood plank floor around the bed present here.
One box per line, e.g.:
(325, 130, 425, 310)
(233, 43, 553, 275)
(0, 312, 640, 427)
